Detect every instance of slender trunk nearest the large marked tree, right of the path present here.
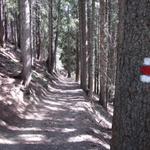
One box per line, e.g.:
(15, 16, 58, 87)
(99, 0, 108, 109)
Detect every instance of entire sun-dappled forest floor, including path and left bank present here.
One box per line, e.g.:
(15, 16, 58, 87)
(0, 45, 112, 150)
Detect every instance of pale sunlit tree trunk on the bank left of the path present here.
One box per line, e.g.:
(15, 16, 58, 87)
(20, 0, 32, 86)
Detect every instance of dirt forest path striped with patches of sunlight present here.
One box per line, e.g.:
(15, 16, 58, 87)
(0, 79, 110, 150)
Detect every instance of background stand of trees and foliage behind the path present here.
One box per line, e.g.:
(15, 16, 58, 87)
(1, 0, 118, 108)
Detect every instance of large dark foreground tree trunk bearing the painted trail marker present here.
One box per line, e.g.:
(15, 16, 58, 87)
(111, 0, 150, 150)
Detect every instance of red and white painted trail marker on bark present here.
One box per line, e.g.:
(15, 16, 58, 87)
(140, 57, 150, 83)
